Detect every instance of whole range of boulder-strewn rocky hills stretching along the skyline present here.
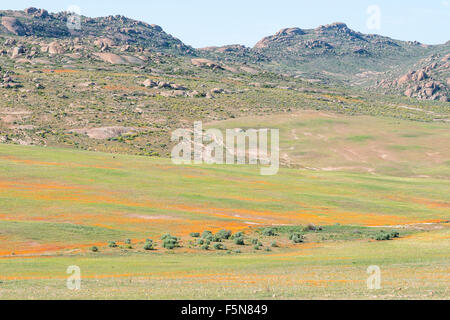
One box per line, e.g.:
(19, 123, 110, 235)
(0, 8, 450, 101)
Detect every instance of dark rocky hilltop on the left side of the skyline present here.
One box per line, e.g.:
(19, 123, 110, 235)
(0, 8, 194, 54)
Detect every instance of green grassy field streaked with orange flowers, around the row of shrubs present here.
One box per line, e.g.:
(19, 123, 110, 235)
(0, 145, 450, 299)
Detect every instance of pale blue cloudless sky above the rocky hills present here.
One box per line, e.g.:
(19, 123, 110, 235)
(0, 0, 450, 48)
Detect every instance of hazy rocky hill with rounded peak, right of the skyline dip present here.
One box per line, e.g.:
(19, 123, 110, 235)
(250, 23, 442, 84)
